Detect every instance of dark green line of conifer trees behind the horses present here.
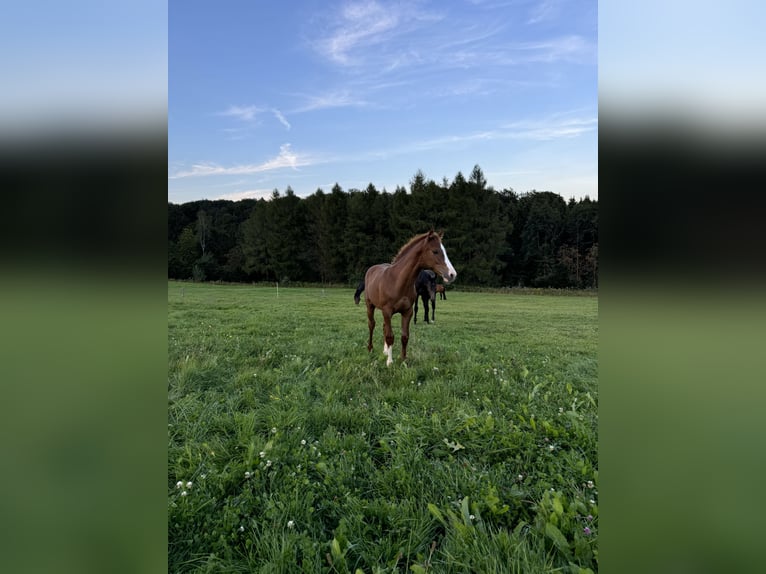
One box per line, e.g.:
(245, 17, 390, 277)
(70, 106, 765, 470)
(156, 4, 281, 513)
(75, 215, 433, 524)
(168, 165, 598, 288)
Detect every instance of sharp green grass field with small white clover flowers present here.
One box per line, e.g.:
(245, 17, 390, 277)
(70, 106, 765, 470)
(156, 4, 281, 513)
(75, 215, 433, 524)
(168, 282, 598, 574)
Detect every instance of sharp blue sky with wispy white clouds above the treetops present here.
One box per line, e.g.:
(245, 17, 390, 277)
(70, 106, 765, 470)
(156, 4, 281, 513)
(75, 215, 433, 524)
(168, 0, 598, 203)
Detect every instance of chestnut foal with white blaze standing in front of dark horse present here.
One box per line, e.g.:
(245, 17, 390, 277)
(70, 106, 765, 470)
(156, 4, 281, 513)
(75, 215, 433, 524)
(354, 231, 457, 365)
